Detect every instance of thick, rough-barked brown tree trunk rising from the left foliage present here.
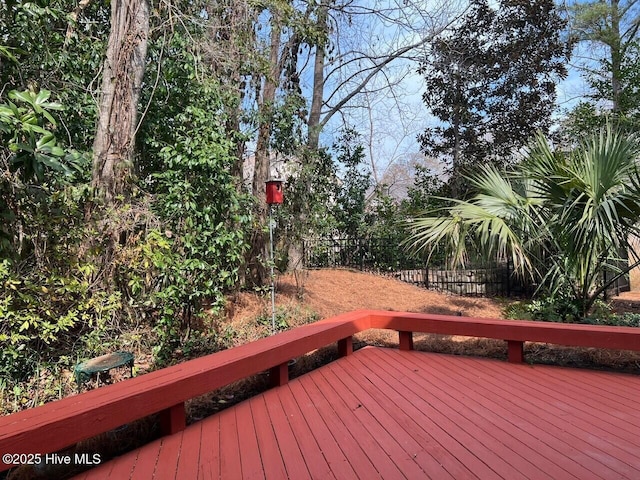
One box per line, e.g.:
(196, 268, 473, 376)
(92, 0, 149, 205)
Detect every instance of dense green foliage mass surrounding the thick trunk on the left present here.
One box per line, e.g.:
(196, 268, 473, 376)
(0, 2, 250, 400)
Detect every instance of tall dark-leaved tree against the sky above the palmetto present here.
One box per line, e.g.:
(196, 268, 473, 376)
(419, 0, 567, 196)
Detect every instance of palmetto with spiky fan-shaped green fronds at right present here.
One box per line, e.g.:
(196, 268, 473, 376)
(408, 126, 640, 315)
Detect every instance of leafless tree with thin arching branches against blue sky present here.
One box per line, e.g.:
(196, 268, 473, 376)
(308, 0, 463, 142)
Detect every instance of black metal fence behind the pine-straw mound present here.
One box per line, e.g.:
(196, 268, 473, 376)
(304, 238, 534, 297)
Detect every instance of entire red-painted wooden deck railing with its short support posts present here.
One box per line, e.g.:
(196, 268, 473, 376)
(0, 310, 640, 471)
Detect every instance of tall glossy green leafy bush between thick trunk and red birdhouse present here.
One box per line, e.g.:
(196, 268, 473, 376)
(147, 100, 250, 357)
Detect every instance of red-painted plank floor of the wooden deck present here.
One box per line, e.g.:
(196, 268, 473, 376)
(76, 347, 640, 480)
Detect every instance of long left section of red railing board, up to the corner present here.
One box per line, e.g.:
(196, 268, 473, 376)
(0, 312, 369, 469)
